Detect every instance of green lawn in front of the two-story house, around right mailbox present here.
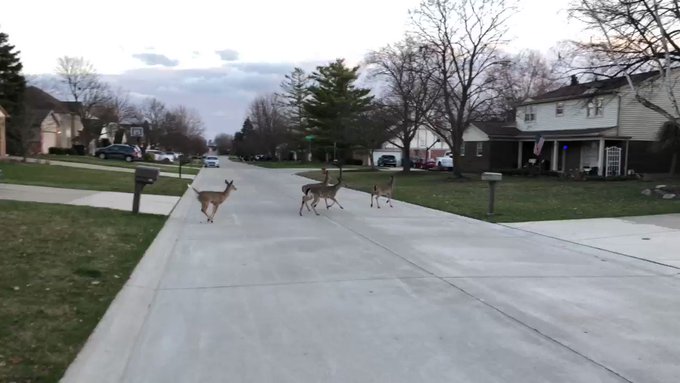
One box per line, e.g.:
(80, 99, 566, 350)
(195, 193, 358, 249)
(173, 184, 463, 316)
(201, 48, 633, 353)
(301, 171, 680, 222)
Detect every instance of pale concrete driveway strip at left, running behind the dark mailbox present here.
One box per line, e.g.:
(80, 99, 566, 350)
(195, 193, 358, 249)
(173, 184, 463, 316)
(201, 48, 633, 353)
(0, 183, 179, 215)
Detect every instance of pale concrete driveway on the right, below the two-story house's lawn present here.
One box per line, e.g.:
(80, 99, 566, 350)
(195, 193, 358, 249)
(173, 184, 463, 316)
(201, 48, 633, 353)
(505, 214, 680, 269)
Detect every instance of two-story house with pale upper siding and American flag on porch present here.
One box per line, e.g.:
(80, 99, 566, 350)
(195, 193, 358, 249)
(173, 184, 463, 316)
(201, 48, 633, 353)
(515, 72, 680, 176)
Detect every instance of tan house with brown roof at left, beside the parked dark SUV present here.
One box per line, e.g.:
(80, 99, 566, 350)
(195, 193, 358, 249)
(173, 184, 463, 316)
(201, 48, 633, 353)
(24, 86, 83, 153)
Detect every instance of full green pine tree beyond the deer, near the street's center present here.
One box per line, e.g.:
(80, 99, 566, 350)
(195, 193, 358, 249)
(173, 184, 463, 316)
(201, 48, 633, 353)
(304, 59, 373, 159)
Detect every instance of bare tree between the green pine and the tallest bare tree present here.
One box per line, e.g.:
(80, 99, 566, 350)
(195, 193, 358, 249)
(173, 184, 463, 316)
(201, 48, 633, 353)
(366, 38, 441, 172)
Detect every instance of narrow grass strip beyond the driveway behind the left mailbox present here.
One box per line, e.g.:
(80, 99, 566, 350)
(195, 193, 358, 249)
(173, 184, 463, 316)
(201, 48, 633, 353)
(0, 162, 190, 196)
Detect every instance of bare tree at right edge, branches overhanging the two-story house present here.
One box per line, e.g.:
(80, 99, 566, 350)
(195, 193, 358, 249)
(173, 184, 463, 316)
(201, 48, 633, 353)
(571, 0, 680, 171)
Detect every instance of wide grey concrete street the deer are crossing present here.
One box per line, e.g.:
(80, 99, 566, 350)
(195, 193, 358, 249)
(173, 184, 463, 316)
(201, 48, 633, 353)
(64, 159, 680, 383)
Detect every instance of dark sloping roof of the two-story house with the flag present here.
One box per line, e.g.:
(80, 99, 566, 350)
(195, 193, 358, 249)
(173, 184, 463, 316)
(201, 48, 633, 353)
(522, 71, 659, 105)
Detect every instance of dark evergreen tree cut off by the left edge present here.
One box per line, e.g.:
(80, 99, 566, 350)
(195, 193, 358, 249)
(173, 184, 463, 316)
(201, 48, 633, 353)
(0, 32, 28, 154)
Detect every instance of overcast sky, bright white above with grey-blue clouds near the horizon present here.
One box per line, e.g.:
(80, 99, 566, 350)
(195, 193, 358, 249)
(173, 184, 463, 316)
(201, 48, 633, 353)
(0, 0, 580, 138)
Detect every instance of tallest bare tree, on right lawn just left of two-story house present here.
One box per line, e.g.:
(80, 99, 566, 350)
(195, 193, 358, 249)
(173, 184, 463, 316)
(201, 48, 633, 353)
(412, 0, 515, 177)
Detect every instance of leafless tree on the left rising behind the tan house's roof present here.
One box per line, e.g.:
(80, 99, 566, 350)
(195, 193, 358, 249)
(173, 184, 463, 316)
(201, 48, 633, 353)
(56, 56, 111, 145)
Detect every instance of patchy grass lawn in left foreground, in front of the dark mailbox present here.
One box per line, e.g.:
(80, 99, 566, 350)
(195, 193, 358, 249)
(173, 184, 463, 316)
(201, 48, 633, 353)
(0, 201, 165, 383)
